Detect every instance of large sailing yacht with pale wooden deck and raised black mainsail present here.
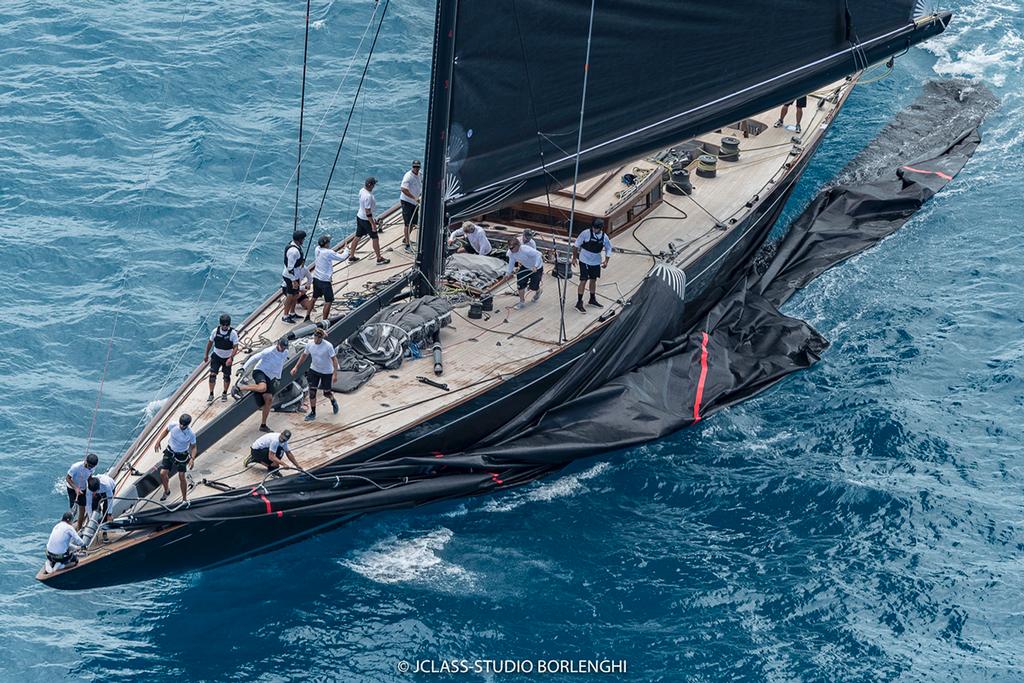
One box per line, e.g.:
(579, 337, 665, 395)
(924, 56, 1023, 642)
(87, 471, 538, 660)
(37, 0, 950, 589)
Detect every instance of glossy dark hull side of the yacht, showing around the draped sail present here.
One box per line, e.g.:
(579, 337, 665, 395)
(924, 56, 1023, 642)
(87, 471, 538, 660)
(41, 138, 820, 590)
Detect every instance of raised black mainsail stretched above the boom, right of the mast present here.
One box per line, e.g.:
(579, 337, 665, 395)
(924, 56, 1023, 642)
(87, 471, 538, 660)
(435, 0, 949, 220)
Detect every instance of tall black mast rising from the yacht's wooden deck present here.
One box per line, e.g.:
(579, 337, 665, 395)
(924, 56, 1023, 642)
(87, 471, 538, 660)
(416, 0, 459, 296)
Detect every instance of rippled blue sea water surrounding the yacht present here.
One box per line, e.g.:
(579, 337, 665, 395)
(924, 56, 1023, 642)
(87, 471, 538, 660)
(0, 0, 1024, 681)
